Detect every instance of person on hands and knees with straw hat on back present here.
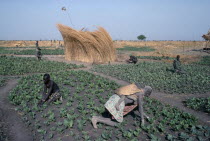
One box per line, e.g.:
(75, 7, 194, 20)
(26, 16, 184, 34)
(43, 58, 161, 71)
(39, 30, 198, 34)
(92, 84, 152, 128)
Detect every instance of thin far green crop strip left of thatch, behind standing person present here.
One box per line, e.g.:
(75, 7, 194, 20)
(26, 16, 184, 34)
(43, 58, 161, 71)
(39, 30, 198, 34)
(0, 47, 64, 55)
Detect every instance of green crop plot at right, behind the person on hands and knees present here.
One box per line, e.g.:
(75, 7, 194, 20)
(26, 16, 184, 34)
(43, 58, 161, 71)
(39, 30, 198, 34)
(92, 62, 210, 94)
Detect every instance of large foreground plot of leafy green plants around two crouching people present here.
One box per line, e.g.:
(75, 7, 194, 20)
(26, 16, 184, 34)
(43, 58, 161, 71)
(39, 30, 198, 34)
(9, 71, 210, 141)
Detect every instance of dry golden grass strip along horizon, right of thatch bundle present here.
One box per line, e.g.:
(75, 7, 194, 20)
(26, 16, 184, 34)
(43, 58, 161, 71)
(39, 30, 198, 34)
(116, 41, 206, 57)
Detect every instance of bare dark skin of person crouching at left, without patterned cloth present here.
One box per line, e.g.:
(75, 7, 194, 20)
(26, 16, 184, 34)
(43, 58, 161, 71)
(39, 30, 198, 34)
(39, 77, 59, 105)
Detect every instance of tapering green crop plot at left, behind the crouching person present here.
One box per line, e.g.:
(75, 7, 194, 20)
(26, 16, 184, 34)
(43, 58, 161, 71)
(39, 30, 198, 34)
(0, 56, 84, 75)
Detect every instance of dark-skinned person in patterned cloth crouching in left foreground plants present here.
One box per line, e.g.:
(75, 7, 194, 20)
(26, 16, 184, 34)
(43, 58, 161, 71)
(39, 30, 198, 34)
(38, 74, 62, 105)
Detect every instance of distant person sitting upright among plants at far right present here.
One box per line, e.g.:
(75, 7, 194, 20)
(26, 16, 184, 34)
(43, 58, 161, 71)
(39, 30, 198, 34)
(166, 55, 185, 74)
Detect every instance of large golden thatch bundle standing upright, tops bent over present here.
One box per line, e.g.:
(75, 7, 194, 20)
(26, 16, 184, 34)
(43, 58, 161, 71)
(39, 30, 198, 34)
(57, 24, 116, 63)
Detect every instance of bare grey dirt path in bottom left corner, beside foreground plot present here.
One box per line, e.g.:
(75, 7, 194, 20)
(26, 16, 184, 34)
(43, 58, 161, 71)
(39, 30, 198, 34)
(0, 79, 33, 141)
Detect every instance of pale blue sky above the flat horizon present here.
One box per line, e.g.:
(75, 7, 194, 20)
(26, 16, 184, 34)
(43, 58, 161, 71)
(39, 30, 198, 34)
(0, 0, 210, 40)
